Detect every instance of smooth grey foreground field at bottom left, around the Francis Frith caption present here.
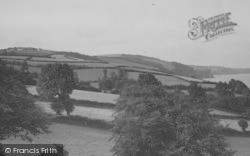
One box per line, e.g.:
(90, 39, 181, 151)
(1, 123, 113, 156)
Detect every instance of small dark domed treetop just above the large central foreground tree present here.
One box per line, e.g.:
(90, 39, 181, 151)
(138, 73, 162, 85)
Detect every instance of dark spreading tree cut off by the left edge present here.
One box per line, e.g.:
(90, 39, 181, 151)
(0, 60, 48, 141)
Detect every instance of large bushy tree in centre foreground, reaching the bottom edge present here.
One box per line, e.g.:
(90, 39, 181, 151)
(112, 85, 175, 156)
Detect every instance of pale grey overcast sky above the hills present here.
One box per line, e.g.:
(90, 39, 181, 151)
(0, 0, 250, 67)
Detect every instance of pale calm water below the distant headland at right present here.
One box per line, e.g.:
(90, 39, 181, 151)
(206, 74, 250, 88)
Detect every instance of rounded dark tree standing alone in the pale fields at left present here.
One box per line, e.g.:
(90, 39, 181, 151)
(37, 64, 75, 115)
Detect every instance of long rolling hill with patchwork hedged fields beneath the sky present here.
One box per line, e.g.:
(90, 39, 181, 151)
(0, 47, 217, 88)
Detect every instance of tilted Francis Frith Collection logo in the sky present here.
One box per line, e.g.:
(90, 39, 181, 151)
(188, 12, 237, 40)
